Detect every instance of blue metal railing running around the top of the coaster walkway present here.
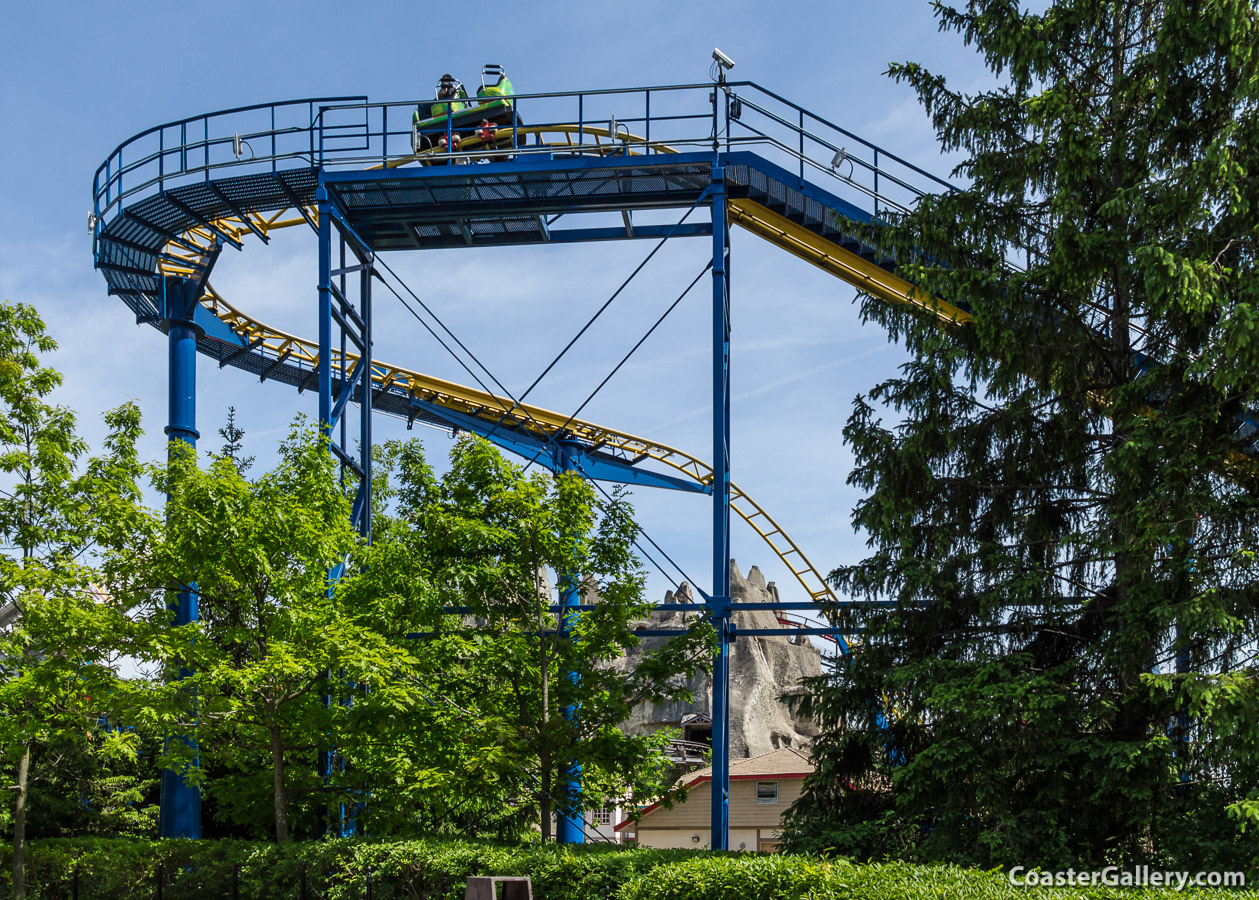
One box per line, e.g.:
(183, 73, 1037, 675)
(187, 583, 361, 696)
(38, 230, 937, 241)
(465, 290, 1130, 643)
(92, 82, 952, 253)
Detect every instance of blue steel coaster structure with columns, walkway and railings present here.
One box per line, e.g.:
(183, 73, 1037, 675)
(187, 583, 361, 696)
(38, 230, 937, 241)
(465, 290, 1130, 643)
(92, 82, 1228, 848)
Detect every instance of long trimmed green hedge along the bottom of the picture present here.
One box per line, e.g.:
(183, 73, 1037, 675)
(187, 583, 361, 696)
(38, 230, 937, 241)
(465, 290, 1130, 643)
(0, 838, 1259, 900)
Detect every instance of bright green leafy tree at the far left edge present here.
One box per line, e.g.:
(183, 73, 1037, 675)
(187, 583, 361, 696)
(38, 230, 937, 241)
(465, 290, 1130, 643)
(0, 303, 140, 897)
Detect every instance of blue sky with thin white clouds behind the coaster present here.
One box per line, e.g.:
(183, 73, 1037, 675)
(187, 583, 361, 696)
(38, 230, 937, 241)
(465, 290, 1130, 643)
(0, 0, 990, 619)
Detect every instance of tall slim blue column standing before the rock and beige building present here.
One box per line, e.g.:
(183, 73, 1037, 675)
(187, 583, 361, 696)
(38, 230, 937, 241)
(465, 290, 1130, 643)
(709, 165, 730, 850)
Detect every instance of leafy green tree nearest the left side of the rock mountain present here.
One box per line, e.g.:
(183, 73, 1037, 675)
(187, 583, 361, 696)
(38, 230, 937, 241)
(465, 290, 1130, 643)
(365, 438, 709, 840)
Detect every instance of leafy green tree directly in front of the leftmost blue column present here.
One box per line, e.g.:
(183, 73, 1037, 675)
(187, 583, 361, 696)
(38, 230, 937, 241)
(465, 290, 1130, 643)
(117, 423, 410, 842)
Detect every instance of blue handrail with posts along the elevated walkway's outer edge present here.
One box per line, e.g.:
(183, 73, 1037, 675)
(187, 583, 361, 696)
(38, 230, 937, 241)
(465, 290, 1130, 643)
(92, 81, 954, 255)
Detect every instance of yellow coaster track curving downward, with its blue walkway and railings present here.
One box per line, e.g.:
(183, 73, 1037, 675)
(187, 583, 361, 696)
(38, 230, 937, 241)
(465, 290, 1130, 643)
(95, 82, 1238, 840)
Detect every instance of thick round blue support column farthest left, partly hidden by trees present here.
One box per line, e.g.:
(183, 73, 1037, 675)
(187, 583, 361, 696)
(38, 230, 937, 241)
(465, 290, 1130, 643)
(157, 277, 203, 840)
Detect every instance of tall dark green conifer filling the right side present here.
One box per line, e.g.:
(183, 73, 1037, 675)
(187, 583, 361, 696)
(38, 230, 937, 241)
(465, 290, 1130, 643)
(791, 0, 1259, 869)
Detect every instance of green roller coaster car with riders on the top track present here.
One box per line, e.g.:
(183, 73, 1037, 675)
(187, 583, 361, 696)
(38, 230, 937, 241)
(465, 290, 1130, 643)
(410, 65, 522, 165)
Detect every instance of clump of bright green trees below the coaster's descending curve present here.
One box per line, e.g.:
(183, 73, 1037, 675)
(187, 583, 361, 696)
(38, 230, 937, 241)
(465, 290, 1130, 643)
(90, 419, 708, 841)
